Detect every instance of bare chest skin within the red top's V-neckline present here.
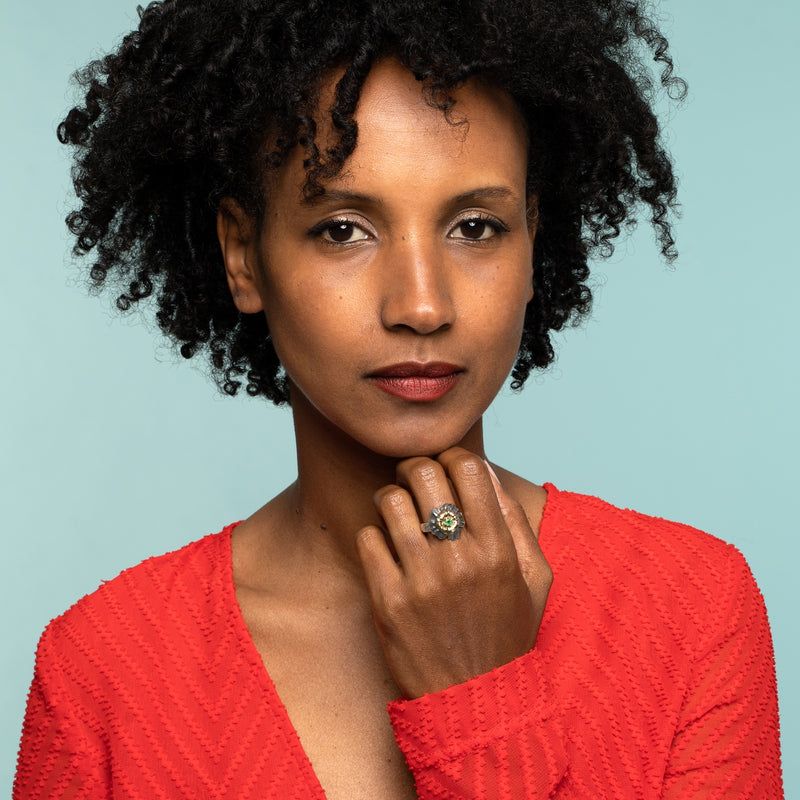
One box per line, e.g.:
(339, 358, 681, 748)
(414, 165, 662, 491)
(237, 580, 416, 800)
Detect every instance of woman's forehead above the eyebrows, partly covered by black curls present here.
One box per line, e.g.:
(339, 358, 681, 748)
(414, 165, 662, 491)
(272, 58, 527, 209)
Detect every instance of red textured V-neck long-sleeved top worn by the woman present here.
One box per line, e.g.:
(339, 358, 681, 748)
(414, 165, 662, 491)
(14, 486, 782, 800)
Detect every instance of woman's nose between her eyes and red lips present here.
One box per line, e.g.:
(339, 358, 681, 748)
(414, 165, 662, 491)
(381, 236, 456, 335)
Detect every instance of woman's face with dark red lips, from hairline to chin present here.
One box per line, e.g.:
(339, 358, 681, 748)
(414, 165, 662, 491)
(229, 60, 534, 457)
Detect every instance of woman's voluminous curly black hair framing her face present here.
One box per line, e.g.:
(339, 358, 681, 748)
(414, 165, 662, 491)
(58, 0, 685, 404)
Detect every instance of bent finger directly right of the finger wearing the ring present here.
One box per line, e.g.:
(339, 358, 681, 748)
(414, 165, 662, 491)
(438, 447, 508, 542)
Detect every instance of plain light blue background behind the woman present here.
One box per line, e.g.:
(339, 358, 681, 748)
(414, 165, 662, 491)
(0, 0, 800, 797)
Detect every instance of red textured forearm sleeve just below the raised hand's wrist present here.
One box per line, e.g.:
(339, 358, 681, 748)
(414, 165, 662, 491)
(389, 649, 567, 800)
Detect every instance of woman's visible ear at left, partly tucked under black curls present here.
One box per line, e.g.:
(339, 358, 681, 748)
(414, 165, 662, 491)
(217, 197, 264, 314)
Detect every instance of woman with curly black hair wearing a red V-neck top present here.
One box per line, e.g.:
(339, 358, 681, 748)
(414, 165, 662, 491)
(15, 0, 781, 798)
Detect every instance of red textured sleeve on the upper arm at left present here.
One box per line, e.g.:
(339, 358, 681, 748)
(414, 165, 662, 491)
(12, 628, 111, 800)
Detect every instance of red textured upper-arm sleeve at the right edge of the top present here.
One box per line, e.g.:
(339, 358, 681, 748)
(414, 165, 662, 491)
(662, 546, 783, 800)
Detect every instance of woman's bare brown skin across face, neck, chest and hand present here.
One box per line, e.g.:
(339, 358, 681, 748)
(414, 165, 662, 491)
(218, 60, 552, 798)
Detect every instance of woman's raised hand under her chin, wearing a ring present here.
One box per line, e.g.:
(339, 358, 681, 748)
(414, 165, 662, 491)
(356, 447, 553, 698)
